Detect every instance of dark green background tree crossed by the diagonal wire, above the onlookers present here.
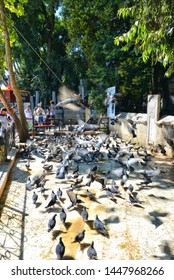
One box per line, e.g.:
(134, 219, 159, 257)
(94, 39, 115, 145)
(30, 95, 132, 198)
(9, 0, 77, 100)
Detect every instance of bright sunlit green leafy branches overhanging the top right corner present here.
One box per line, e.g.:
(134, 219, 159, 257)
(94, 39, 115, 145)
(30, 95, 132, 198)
(114, 0, 174, 76)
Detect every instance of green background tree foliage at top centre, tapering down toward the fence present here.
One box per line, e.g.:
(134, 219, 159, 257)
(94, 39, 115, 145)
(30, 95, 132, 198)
(62, 0, 131, 113)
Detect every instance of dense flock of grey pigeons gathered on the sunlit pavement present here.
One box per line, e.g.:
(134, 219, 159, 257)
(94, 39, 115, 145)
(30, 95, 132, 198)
(19, 127, 163, 260)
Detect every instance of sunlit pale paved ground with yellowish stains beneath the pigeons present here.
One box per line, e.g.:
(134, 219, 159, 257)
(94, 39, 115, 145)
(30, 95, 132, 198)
(0, 133, 174, 260)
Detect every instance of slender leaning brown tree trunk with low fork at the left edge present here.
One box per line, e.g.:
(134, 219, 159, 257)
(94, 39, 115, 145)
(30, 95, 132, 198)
(0, 0, 29, 142)
